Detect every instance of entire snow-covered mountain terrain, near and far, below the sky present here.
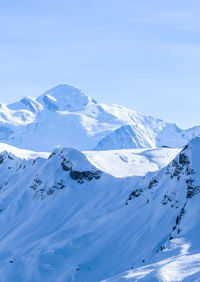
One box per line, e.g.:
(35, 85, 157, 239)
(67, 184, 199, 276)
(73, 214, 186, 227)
(0, 82, 200, 282)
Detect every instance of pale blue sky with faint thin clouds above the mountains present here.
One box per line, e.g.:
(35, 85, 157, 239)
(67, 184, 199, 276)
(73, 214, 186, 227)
(0, 0, 200, 128)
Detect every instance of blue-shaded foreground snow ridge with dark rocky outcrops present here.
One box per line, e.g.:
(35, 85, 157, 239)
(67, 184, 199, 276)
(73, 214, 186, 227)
(0, 138, 200, 282)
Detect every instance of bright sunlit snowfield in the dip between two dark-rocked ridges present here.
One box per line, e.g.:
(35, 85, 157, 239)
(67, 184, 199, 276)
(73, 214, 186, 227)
(83, 148, 180, 177)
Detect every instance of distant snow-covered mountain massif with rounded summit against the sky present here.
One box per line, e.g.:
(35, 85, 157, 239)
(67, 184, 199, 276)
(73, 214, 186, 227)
(0, 82, 200, 151)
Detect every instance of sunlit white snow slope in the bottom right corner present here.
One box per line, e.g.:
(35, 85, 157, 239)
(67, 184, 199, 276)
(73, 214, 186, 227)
(104, 243, 200, 282)
